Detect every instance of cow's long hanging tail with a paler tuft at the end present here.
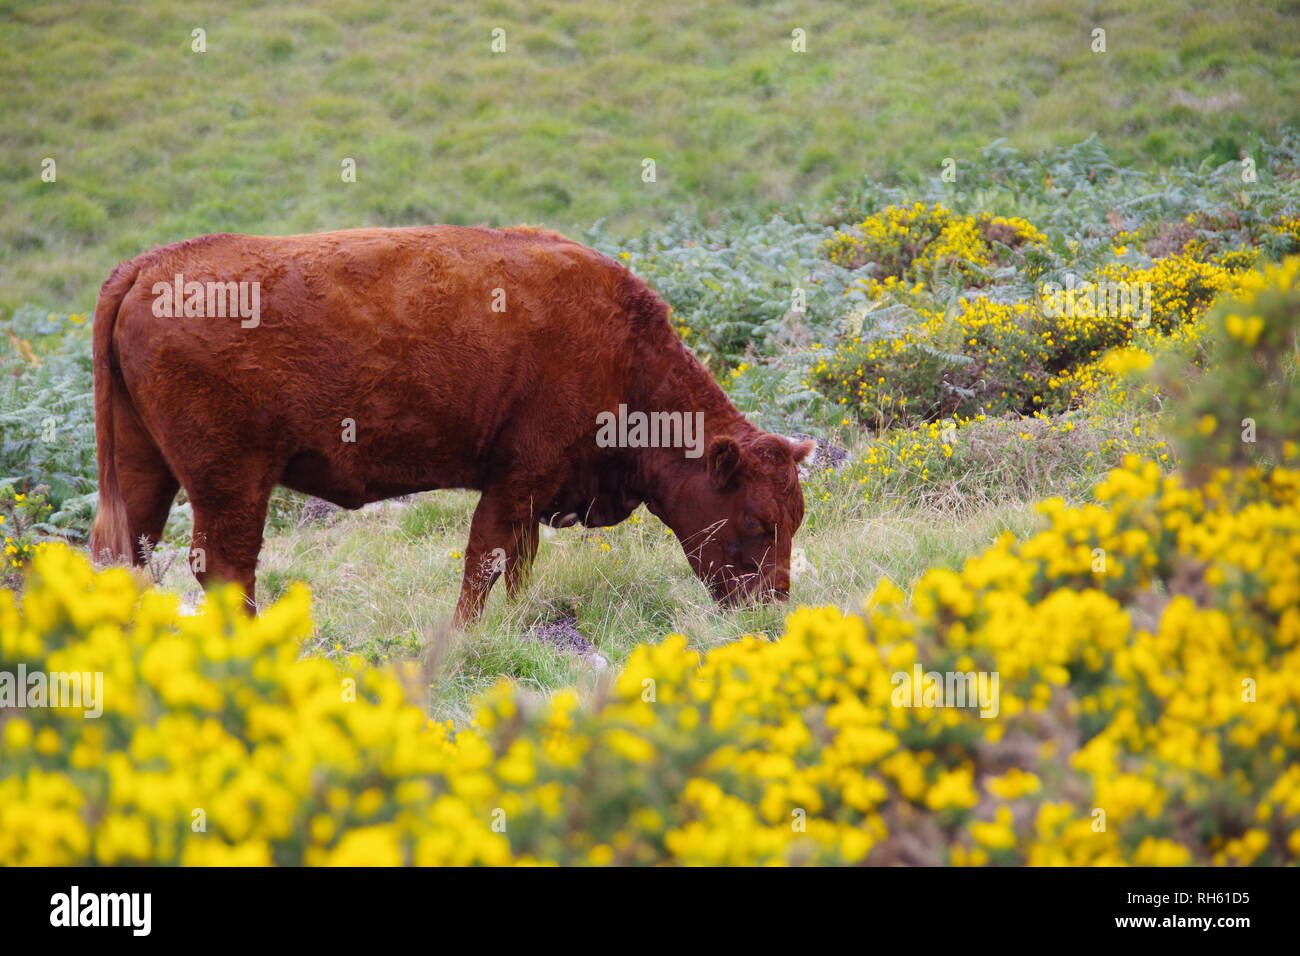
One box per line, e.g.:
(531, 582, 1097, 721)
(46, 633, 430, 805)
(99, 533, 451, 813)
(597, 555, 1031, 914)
(90, 261, 139, 563)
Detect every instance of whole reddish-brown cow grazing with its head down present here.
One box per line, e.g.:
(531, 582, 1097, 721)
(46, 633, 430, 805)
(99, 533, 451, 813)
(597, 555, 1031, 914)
(91, 226, 811, 623)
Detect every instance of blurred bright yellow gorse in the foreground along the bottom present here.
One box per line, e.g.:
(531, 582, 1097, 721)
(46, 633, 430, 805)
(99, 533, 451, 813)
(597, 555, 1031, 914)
(0, 260, 1300, 865)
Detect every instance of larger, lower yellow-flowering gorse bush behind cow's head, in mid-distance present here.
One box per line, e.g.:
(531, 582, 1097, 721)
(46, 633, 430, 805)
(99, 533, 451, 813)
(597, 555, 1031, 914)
(813, 220, 1255, 429)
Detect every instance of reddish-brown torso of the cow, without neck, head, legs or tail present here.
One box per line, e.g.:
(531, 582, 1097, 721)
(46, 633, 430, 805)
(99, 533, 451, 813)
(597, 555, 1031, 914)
(113, 226, 636, 503)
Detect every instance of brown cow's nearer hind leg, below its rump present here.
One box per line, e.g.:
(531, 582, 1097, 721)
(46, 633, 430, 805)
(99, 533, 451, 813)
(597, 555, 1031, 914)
(187, 460, 277, 613)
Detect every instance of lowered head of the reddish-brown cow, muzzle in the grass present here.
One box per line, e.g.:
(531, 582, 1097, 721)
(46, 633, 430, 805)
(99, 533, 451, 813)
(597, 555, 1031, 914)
(657, 434, 814, 605)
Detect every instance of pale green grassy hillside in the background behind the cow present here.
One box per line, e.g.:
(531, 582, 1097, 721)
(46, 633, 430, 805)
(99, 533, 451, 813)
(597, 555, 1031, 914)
(0, 0, 1300, 311)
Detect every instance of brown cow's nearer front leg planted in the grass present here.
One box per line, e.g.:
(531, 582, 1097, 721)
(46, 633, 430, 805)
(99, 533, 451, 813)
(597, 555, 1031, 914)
(455, 489, 537, 627)
